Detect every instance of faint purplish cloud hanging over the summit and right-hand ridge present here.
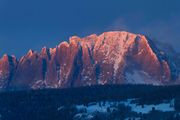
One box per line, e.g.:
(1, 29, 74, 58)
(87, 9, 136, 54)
(107, 15, 180, 52)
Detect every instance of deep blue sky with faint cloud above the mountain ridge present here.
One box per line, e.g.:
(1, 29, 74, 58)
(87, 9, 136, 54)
(0, 0, 180, 57)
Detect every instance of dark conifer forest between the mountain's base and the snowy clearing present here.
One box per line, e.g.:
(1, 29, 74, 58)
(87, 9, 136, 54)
(0, 85, 180, 120)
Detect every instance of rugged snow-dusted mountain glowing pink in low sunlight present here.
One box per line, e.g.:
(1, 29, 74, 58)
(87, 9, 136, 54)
(0, 31, 180, 90)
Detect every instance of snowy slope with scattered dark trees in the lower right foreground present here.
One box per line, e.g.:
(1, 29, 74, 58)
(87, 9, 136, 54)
(61, 99, 178, 120)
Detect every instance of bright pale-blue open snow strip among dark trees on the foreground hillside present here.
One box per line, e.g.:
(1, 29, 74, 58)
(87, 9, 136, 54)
(76, 99, 175, 114)
